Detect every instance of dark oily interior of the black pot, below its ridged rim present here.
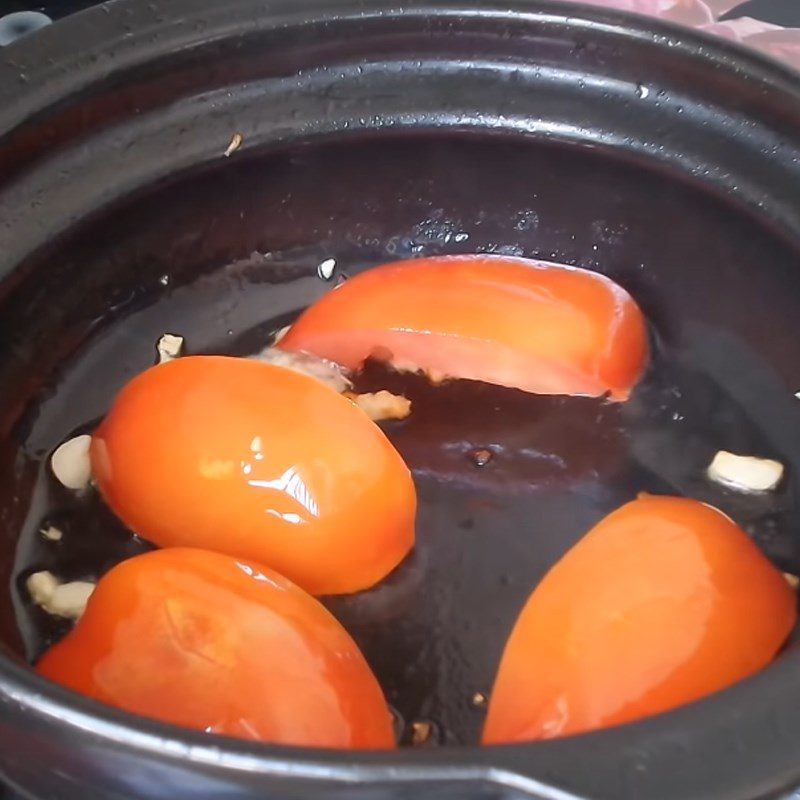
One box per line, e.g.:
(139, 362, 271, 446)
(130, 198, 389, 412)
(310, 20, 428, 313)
(0, 132, 800, 744)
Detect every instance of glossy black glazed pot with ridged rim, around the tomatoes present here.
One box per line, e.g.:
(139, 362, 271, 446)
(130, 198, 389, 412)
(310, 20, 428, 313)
(0, 0, 800, 800)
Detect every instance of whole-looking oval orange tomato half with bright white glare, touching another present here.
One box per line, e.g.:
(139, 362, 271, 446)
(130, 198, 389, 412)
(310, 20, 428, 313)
(91, 356, 416, 594)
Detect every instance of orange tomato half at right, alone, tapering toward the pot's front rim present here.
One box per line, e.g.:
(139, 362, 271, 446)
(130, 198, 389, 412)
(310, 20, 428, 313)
(483, 496, 797, 744)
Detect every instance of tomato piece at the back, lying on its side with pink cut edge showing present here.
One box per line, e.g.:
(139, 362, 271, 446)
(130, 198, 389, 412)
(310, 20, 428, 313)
(278, 256, 648, 400)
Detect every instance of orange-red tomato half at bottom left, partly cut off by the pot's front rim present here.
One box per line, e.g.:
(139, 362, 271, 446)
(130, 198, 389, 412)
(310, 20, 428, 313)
(36, 548, 394, 748)
